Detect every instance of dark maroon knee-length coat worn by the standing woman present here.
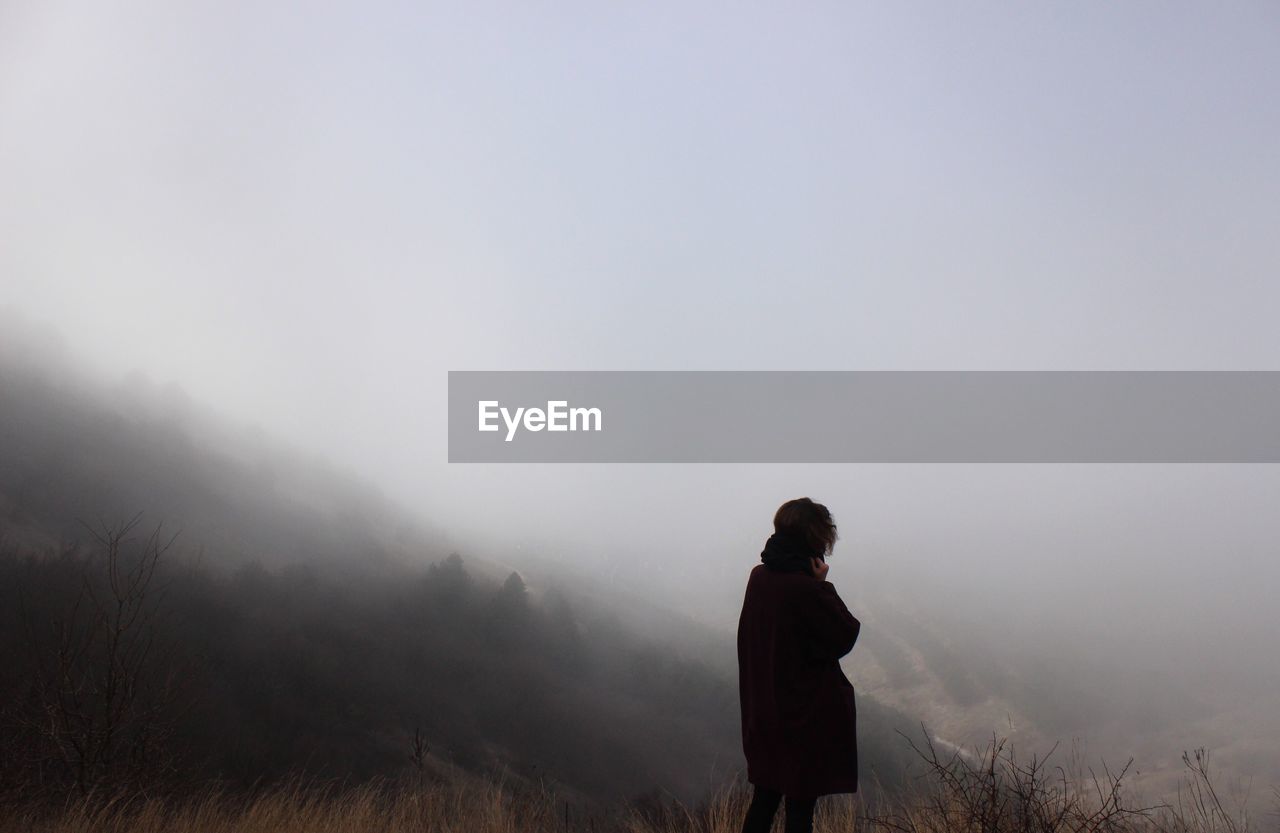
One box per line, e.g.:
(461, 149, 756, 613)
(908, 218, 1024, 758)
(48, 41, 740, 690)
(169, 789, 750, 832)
(737, 564, 861, 798)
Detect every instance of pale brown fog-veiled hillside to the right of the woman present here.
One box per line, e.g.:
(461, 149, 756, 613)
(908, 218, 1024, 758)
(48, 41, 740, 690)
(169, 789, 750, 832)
(845, 580, 1280, 809)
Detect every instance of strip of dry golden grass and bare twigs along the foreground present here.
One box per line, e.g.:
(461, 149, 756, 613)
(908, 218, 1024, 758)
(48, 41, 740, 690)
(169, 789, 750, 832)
(0, 734, 1280, 833)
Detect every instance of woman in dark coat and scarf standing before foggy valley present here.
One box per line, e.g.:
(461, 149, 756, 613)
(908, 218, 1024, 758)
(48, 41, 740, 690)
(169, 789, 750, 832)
(737, 498, 861, 833)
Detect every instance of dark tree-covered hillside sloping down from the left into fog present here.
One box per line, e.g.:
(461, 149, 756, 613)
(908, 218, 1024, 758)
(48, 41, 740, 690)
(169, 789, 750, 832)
(0, 314, 910, 800)
